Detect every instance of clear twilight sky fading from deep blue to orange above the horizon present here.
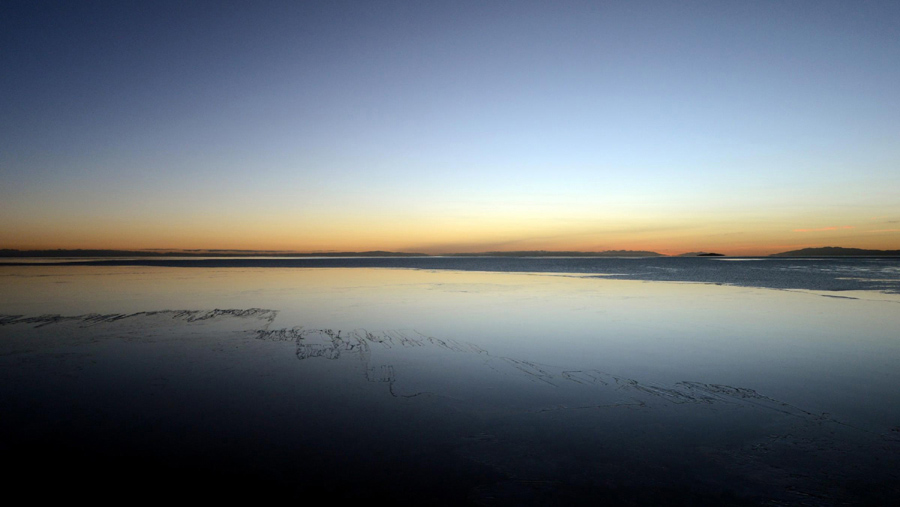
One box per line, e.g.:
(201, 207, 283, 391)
(0, 0, 900, 255)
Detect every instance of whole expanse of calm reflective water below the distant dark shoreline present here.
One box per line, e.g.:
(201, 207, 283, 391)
(0, 259, 900, 505)
